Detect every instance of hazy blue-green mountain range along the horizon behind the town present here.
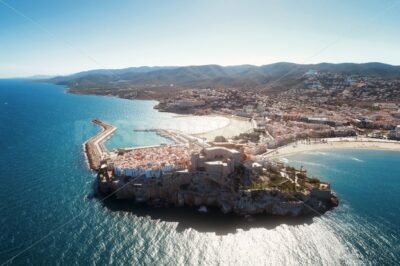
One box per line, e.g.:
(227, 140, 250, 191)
(47, 62, 400, 92)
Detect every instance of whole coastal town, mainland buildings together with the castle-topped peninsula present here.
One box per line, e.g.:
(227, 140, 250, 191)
(77, 67, 400, 216)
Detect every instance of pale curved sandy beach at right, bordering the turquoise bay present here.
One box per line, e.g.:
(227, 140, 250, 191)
(264, 137, 400, 158)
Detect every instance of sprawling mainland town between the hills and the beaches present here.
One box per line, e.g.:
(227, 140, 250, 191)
(155, 70, 400, 148)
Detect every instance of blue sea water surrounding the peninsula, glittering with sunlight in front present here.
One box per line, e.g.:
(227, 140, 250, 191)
(0, 80, 400, 265)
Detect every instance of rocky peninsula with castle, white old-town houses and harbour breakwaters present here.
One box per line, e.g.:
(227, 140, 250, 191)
(85, 120, 338, 216)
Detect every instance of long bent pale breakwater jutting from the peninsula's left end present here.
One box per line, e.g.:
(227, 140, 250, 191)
(85, 119, 117, 171)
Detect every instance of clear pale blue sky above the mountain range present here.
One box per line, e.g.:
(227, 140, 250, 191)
(0, 0, 400, 77)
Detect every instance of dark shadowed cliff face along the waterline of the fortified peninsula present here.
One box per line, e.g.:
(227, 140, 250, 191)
(100, 173, 337, 216)
